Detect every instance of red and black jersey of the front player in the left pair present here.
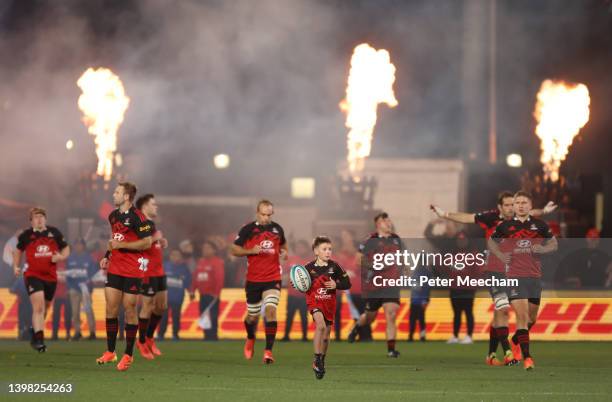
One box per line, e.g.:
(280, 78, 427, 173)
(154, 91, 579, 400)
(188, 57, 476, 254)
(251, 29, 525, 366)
(108, 206, 154, 278)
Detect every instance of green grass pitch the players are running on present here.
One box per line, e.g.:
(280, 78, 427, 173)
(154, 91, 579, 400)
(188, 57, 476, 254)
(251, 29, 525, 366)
(0, 341, 612, 402)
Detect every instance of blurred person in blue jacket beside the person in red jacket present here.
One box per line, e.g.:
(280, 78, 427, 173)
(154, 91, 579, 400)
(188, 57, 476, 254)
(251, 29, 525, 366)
(157, 249, 191, 341)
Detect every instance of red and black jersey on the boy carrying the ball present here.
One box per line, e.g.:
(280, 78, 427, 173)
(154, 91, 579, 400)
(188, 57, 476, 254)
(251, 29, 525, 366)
(304, 260, 351, 321)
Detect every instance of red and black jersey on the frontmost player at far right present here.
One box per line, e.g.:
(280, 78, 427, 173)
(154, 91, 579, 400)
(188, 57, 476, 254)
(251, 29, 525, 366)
(491, 217, 554, 278)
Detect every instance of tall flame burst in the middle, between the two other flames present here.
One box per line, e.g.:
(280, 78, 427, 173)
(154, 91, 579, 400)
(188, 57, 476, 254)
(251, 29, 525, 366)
(340, 43, 397, 181)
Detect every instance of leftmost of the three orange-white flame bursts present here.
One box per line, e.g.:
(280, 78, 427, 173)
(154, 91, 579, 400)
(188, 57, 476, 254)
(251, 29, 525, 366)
(77, 68, 130, 181)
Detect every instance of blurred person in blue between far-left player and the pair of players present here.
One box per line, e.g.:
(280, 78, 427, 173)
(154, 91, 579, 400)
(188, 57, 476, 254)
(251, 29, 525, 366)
(66, 239, 98, 341)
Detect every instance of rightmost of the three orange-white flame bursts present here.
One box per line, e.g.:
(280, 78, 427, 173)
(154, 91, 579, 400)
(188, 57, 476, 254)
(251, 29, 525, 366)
(534, 80, 591, 182)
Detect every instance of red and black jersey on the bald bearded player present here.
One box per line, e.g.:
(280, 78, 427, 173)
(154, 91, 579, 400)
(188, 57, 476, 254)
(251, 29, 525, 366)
(234, 222, 286, 282)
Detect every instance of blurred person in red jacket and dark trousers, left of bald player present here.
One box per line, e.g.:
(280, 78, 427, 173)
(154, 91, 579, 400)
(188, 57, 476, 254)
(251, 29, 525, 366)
(190, 240, 225, 341)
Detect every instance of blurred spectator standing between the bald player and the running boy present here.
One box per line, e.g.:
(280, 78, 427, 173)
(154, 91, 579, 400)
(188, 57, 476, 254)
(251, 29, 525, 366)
(281, 240, 312, 342)
